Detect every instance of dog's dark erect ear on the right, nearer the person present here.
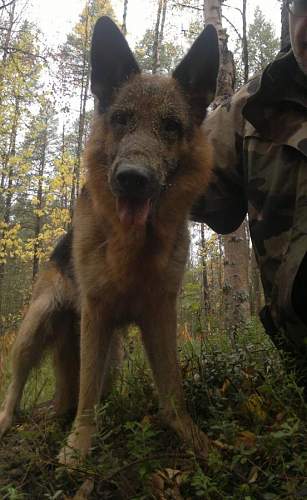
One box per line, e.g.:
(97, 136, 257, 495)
(173, 24, 219, 123)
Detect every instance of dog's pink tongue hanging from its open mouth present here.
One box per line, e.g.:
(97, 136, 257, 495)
(117, 198, 150, 226)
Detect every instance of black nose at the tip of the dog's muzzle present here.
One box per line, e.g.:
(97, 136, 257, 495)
(114, 164, 155, 198)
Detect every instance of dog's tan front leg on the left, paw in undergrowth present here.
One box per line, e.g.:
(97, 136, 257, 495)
(59, 301, 112, 466)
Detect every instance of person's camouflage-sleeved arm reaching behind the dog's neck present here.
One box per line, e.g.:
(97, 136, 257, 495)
(191, 88, 247, 234)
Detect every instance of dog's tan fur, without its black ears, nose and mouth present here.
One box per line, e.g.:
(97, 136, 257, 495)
(0, 17, 219, 464)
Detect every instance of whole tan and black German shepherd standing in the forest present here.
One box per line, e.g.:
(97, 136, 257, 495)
(0, 17, 219, 465)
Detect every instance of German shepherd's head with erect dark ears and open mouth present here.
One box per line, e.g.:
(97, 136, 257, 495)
(91, 17, 219, 226)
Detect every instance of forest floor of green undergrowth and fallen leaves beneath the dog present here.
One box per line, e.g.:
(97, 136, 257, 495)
(0, 323, 307, 500)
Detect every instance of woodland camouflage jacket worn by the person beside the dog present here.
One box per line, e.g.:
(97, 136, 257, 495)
(192, 51, 307, 349)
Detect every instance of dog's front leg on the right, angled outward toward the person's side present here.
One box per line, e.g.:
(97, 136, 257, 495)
(141, 297, 208, 457)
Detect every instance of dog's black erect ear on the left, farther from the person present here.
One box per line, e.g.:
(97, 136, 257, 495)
(91, 16, 140, 111)
